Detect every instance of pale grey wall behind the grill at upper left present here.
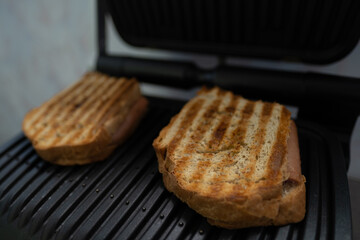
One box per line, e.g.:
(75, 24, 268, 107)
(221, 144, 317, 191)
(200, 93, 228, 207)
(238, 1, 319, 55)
(0, 0, 95, 144)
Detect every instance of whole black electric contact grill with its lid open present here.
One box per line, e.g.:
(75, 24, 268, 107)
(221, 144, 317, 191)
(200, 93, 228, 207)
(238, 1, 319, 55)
(0, 0, 360, 239)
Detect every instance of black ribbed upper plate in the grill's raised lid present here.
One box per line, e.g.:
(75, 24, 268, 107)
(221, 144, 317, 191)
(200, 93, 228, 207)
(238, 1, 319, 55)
(106, 0, 360, 62)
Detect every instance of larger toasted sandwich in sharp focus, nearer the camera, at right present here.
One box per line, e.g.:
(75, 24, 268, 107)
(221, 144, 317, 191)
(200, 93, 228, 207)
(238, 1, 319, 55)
(153, 87, 305, 228)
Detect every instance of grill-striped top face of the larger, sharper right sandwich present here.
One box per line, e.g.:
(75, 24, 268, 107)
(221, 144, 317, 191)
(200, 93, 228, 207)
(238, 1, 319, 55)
(155, 88, 290, 198)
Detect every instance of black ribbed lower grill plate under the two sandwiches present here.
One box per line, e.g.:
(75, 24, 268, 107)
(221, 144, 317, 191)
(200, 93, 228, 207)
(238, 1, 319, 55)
(0, 99, 351, 239)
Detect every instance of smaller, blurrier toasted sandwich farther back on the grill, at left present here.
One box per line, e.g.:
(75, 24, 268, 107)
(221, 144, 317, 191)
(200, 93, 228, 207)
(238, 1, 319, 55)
(22, 72, 147, 165)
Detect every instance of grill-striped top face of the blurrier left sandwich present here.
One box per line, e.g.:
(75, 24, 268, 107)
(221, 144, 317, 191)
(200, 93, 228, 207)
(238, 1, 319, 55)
(23, 72, 140, 148)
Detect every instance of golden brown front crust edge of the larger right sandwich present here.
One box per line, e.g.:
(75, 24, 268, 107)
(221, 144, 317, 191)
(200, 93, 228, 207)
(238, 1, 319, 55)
(162, 153, 305, 229)
